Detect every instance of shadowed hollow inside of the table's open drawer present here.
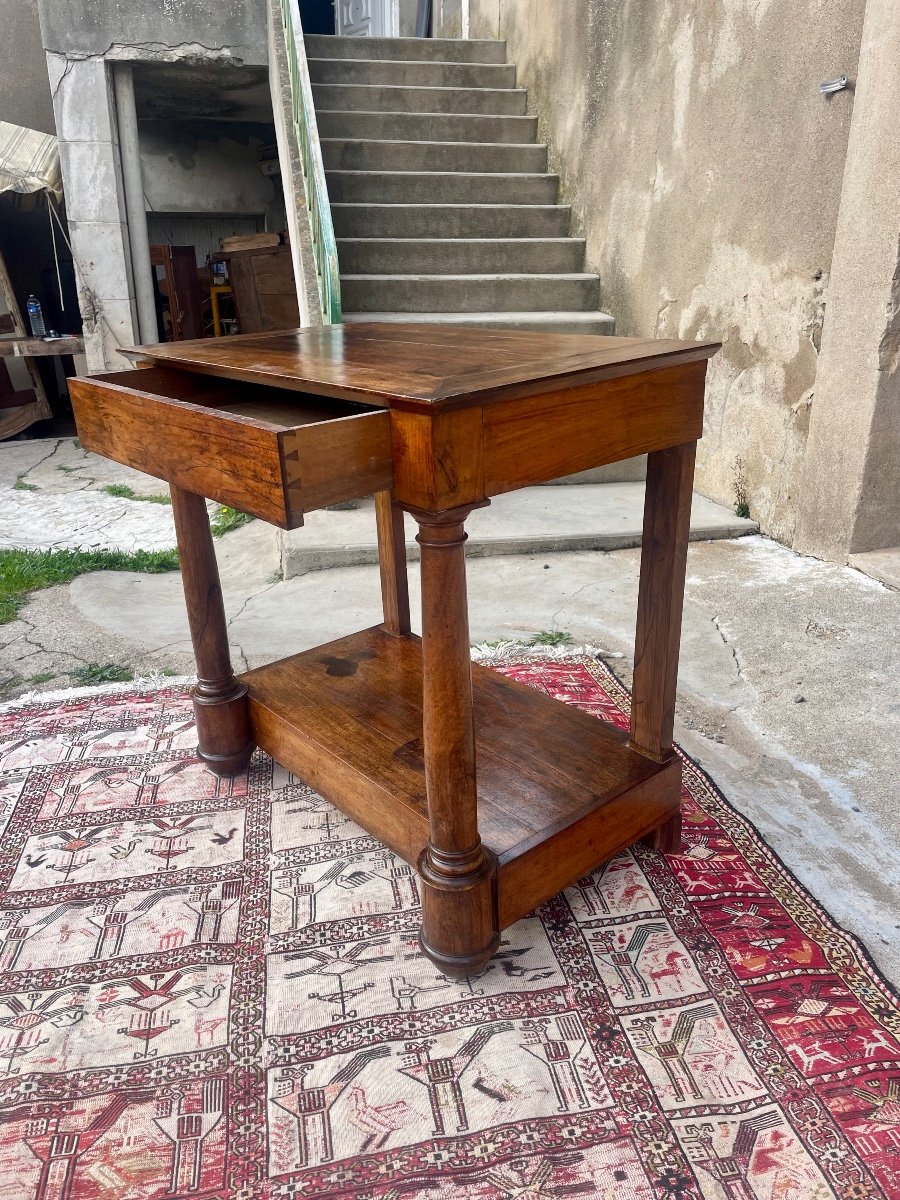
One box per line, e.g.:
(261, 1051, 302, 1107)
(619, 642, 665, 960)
(100, 367, 383, 432)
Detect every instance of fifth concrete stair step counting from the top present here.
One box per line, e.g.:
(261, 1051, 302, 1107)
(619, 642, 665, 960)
(322, 137, 547, 174)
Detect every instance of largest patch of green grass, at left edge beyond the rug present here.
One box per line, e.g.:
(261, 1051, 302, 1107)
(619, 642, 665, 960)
(0, 550, 179, 625)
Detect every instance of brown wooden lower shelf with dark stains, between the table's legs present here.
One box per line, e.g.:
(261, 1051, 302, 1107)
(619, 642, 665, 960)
(241, 628, 680, 928)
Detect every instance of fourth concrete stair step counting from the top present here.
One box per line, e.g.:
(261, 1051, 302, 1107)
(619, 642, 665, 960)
(316, 106, 538, 145)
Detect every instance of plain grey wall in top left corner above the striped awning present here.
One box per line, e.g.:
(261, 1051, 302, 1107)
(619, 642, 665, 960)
(0, 0, 55, 133)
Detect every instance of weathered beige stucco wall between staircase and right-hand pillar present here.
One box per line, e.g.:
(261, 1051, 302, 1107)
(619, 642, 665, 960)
(470, 0, 864, 544)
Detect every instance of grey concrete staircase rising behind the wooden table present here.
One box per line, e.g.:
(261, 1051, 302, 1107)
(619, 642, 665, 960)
(306, 36, 613, 334)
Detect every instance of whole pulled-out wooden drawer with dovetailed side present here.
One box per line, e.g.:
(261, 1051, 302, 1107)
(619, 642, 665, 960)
(68, 367, 392, 529)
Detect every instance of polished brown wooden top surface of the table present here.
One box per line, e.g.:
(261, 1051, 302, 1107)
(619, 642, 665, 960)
(122, 322, 720, 412)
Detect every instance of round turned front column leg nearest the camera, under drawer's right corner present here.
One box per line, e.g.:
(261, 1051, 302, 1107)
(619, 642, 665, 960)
(414, 509, 500, 978)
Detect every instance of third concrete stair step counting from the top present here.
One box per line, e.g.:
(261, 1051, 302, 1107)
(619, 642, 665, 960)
(312, 83, 527, 116)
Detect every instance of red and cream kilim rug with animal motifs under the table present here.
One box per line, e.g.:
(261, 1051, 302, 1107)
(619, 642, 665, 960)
(0, 654, 900, 1200)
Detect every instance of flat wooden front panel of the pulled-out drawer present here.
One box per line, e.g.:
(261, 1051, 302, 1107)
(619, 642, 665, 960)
(70, 371, 296, 526)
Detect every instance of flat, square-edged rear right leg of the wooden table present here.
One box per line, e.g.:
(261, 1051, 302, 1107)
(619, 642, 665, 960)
(631, 442, 696, 852)
